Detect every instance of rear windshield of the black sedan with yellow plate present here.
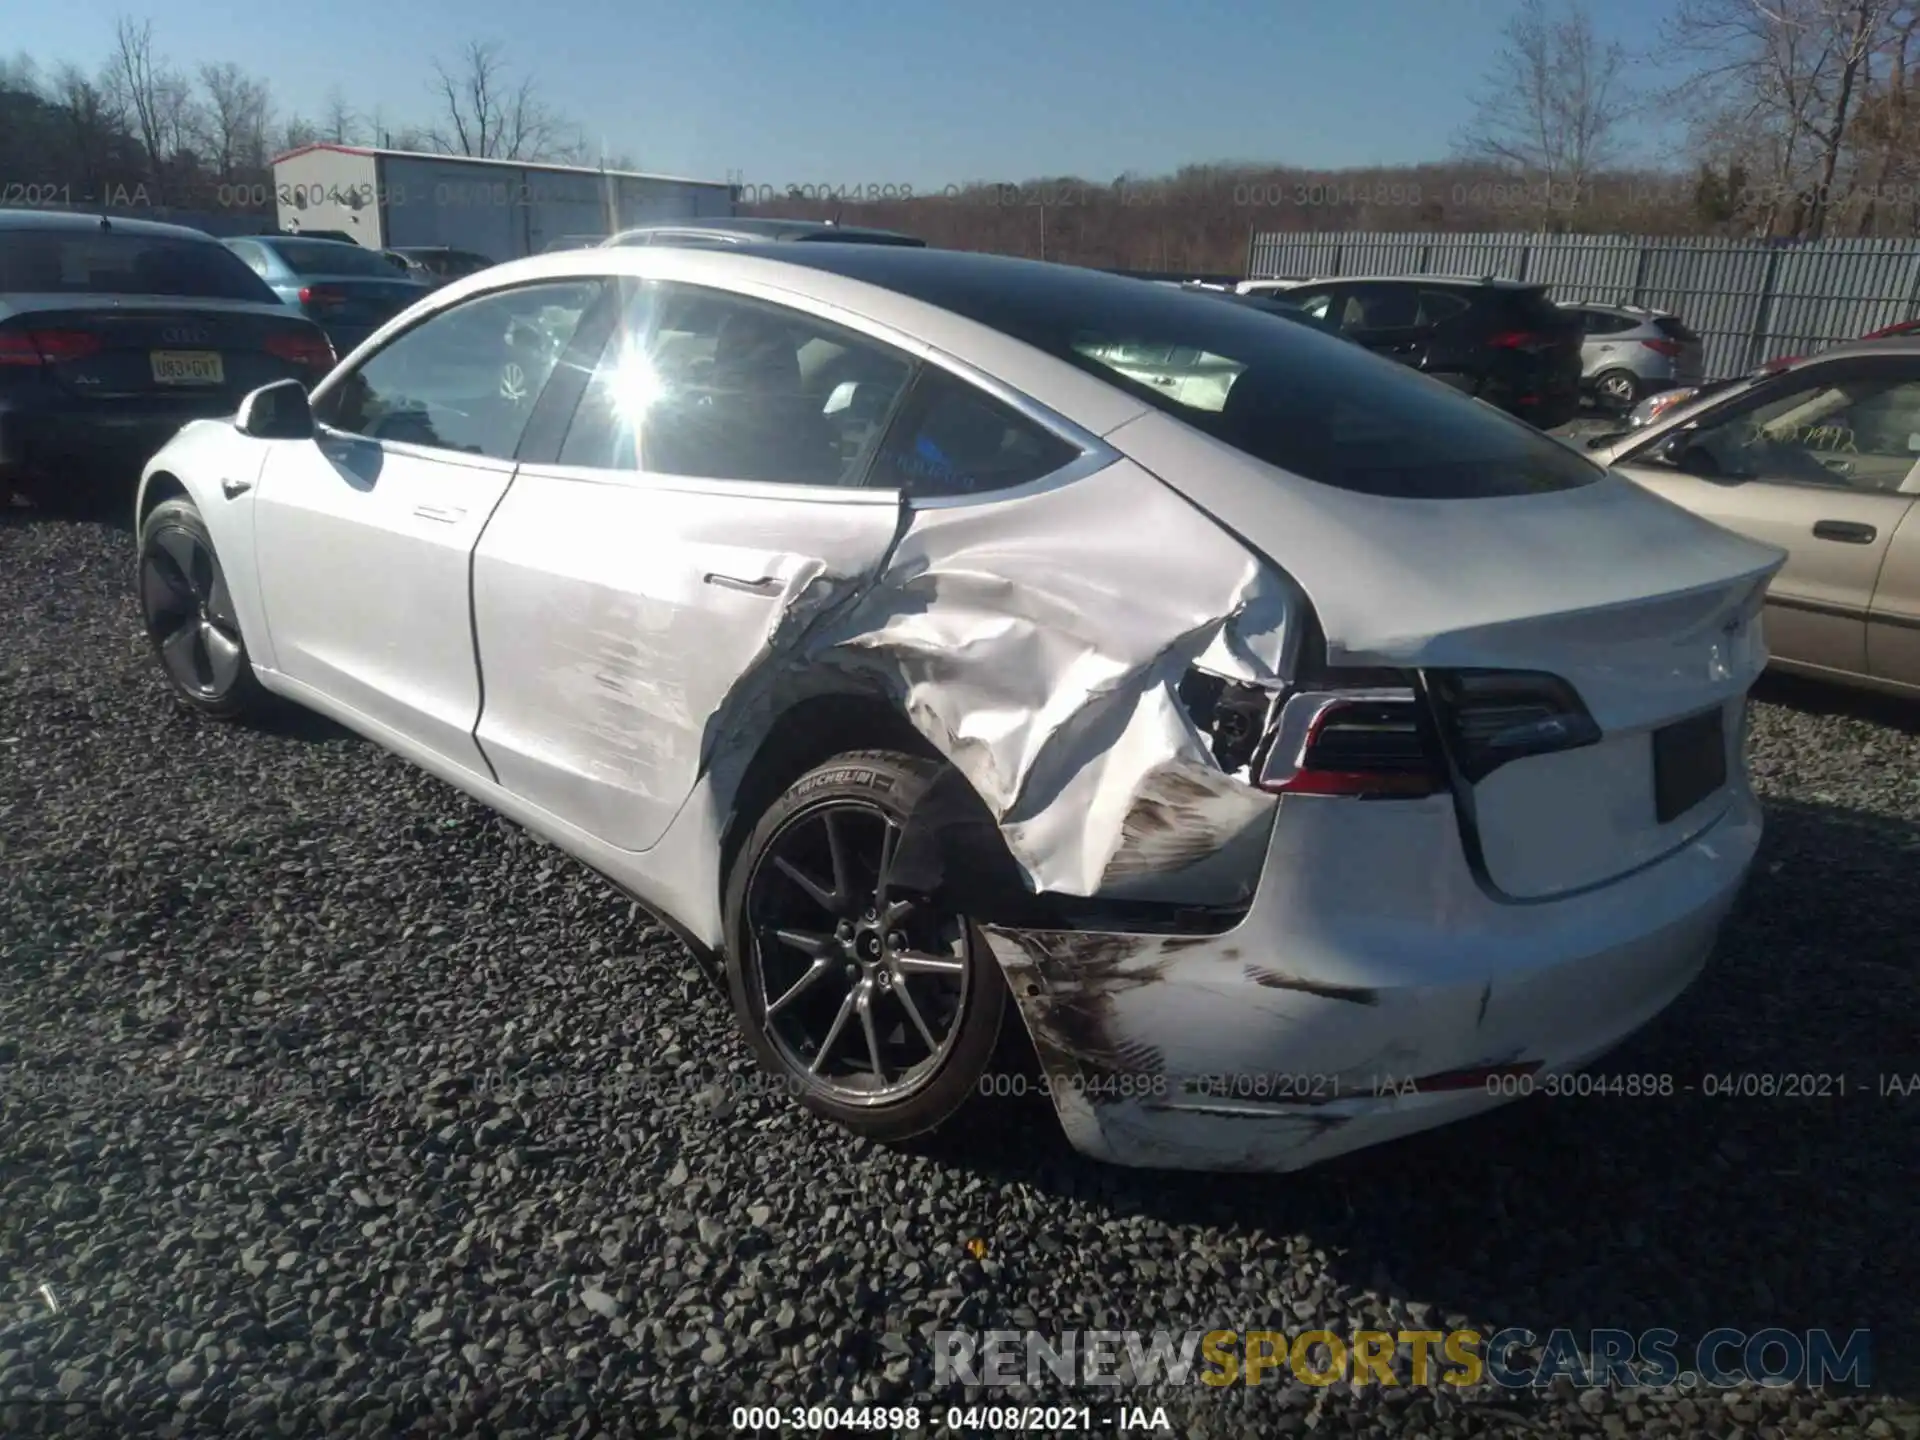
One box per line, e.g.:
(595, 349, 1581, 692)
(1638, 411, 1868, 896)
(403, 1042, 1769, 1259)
(0, 230, 275, 303)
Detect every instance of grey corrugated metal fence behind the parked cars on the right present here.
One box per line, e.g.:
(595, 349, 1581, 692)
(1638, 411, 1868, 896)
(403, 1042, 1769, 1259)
(1246, 232, 1920, 378)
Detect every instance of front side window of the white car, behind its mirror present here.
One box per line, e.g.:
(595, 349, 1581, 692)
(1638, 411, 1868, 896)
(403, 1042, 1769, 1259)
(319, 280, 603, 459)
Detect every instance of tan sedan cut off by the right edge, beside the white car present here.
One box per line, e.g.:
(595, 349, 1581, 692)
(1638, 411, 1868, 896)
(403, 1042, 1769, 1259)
(1592, 340, 1920, 695)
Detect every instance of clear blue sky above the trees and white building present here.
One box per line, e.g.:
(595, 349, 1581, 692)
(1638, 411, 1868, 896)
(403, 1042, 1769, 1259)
(18, 0, 1697, 192)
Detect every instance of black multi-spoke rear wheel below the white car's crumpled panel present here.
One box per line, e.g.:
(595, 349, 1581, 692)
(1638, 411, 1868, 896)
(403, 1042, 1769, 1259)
(726, 751, 1006, 1140)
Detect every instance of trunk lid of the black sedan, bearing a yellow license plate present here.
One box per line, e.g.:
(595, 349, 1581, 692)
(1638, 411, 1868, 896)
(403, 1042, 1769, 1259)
(0, 296, 323, 403)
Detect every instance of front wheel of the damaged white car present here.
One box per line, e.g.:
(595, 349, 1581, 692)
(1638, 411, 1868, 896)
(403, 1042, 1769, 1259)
(138, 499, 269, 720)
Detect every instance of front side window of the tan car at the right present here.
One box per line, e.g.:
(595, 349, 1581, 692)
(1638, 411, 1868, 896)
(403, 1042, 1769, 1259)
(1661, 376, 1920, 493)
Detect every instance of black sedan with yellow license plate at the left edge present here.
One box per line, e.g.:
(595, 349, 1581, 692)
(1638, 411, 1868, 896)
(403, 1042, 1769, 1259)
(0, 209, 334, 509)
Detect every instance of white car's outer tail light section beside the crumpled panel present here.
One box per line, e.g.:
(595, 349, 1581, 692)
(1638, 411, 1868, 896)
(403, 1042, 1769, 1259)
(1260, 687, 1446, 799)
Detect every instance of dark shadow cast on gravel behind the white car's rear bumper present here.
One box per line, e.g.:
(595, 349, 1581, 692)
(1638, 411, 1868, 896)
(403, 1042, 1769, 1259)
(939, 803, 1920, 1396)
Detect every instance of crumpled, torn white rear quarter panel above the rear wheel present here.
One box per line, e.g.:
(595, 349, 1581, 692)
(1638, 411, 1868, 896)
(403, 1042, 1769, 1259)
(716, 461, 1304, 897)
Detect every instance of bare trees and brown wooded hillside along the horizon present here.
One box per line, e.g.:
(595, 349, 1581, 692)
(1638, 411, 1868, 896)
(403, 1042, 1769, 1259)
(11, 0, 1920, 273)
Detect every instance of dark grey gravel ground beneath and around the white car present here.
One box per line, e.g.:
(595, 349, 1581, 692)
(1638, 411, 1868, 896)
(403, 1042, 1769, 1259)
(0, 511, 1920, 1440)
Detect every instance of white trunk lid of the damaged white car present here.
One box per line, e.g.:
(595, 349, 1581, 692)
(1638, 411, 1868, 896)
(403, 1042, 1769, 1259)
(1108, 415, 1784, 899)
